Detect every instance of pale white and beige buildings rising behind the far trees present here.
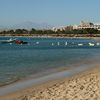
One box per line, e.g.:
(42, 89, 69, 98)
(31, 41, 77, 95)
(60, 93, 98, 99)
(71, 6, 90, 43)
(52, 21, 100, 32)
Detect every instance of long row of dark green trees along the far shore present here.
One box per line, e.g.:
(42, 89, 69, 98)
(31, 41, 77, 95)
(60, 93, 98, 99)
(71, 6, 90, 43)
(0, 26, 100, 36)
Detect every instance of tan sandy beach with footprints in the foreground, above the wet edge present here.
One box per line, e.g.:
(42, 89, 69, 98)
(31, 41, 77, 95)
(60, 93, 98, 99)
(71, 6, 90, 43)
(0, 67, 100, 100)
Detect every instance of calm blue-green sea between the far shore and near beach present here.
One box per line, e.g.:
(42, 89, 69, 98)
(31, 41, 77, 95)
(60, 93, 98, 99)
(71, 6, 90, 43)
(0, 37, 100, 86)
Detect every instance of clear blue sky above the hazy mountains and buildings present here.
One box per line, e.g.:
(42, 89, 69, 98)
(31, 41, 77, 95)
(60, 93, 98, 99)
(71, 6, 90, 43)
(0, 0, 100, 26)
